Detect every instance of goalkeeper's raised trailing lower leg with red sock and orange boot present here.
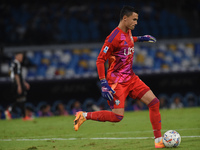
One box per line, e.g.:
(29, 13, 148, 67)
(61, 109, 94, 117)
(74, 108, 124, 131)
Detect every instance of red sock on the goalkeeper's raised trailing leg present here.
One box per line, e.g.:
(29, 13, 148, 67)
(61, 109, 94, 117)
(86, 110, 124, 122)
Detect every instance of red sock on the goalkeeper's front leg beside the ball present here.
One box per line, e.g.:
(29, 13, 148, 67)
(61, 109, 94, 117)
(148, 98, 162, 138)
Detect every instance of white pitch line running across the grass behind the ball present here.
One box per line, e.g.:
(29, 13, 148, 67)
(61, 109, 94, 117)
(0, 135, 200, 142)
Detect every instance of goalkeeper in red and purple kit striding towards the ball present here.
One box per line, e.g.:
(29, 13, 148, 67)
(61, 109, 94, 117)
(74, 6, 165, 148)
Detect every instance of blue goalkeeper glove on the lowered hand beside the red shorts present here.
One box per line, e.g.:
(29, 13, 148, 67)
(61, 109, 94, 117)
(100, 79, 115, 101)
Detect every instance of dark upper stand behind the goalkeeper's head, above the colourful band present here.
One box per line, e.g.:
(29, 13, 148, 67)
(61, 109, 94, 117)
(0, 0, 200, 46)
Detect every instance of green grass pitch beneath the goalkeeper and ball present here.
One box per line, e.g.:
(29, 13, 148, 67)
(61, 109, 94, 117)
(0, 107, 200, 150)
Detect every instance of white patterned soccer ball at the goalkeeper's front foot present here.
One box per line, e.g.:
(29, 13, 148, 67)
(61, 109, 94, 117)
(163, 130, 181, 147)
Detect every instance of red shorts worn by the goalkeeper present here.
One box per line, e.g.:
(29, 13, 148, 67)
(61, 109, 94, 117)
(107, 75, 150, 109)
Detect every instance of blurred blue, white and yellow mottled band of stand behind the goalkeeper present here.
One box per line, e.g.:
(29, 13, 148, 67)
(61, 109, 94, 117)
(1, 41, 200, 79)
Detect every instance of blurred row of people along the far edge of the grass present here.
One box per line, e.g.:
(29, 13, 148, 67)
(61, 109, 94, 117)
(0, 92, 200, 119)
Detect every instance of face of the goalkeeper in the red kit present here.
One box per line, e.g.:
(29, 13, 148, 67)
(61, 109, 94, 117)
(124, 12, 138, 30)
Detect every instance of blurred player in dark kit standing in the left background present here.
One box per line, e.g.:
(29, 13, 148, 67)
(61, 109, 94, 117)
(5, 52, 32, 120)
